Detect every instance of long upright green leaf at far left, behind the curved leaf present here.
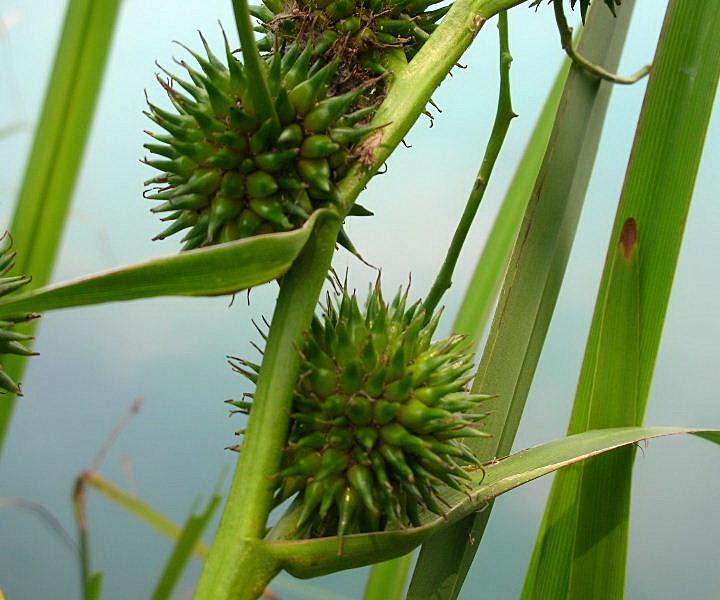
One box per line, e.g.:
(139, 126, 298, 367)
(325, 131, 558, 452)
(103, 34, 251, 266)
(0, 0, 120, 452)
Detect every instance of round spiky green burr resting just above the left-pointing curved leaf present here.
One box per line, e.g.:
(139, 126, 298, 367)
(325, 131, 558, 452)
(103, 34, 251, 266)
(145, 36, 372, 250)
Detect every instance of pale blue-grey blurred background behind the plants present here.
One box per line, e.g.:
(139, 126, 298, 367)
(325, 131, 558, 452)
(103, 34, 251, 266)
(0, 0, 720, 600)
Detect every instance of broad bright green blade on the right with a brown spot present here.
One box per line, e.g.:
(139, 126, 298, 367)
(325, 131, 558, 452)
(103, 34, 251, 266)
(523, 0, 720, 599)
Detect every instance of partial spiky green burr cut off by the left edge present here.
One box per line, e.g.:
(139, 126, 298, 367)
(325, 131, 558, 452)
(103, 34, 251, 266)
(0, 233, 38, 396)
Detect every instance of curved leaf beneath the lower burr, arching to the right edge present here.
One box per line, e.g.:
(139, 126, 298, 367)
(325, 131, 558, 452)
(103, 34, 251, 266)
(266, 427, 720, 578)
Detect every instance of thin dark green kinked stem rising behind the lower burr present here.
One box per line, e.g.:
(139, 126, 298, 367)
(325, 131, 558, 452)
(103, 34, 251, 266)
(424, 12, 517, 319)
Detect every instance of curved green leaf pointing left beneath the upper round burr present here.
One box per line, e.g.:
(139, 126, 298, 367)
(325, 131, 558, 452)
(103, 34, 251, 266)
(0, 209, 337, 317)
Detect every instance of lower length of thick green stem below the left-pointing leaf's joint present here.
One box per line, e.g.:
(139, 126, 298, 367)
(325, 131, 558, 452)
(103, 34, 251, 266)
(196, 213, 340, 600)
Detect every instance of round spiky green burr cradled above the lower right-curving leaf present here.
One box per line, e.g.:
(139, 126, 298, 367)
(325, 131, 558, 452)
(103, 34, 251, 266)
(233, 285, 487, 538)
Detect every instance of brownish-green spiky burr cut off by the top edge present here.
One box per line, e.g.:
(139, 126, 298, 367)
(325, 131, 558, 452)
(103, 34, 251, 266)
(251, 0, 450, 94)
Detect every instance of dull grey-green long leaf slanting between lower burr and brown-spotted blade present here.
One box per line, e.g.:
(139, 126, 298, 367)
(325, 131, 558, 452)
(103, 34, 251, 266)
(408, 1, 634, 600)
